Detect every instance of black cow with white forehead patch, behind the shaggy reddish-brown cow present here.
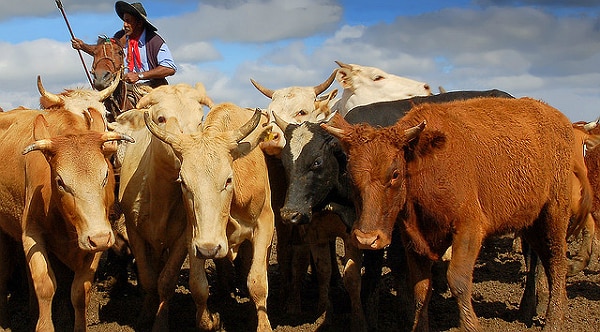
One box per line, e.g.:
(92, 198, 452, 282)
(277, 90, 513, 327)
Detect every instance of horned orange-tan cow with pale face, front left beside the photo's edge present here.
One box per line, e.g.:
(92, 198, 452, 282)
(0, 108, 132, 331)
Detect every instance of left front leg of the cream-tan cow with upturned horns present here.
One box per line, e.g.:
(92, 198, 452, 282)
(188, 254, 221, 331)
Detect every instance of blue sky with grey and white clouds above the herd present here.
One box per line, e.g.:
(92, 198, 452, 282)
(0, 0, 600, 121)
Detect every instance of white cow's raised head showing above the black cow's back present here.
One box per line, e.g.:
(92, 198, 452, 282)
(331, 61, 431, 116)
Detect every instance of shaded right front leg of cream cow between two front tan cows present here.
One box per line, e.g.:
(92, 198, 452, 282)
(152, 238, 187, 332)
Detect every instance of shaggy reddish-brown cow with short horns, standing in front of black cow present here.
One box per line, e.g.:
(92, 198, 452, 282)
(323, 98, 591, 331)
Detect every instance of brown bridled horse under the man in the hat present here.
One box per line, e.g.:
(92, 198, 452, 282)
(90, 35, 151, 122)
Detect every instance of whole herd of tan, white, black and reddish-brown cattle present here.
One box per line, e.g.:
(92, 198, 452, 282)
(0, 61, 600, 331)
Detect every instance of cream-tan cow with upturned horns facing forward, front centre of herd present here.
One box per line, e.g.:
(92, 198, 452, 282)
(146, 103, 275, 331)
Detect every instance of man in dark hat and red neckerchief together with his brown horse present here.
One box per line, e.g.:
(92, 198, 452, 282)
(71, 1, 177, 121)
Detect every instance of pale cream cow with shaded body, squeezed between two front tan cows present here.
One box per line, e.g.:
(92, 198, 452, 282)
(113, 83, 212, 331)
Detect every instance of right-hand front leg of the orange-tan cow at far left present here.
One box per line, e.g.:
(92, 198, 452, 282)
(71, 252, 102, 332)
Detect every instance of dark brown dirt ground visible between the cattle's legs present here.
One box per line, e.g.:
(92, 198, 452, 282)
(0, 233, 600, 332)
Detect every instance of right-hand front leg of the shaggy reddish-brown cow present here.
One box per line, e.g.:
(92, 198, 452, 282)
(447, 230, 483, 331)
